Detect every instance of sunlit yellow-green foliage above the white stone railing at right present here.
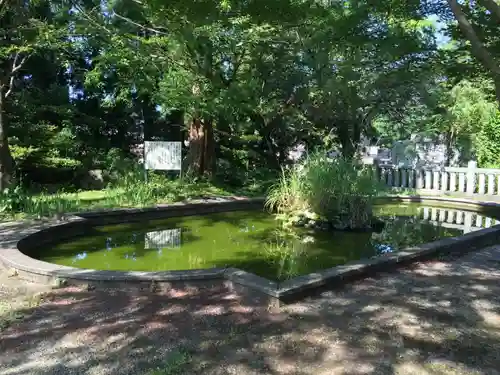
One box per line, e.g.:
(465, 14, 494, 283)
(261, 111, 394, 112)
(375, 79, 497, 165)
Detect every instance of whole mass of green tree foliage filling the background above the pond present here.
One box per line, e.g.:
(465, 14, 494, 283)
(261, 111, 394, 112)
(0, 0, 500, 204)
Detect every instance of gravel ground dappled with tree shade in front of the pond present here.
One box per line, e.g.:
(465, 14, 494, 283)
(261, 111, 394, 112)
(0, 246, 500, 375)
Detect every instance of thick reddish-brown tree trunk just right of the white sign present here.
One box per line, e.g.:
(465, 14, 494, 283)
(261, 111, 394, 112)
(186, 118, 216, 176)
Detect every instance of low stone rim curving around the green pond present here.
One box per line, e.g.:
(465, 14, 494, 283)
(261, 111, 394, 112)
(0, 196, 500, 302)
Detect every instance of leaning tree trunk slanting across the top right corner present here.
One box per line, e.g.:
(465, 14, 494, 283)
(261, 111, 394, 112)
(446, 0, 500, 108)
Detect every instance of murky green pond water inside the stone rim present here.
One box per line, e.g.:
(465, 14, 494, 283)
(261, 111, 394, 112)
(29, 204, 492, 281)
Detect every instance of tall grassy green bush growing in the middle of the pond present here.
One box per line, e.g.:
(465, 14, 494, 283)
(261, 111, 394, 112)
(266, 153, 383, 228)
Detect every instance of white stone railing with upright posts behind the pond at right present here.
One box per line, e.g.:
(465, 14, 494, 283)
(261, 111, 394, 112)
(377, 161, 500, 196)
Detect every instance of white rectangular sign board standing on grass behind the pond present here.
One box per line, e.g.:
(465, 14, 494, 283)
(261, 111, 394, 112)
(144, 141, 182, 171)
